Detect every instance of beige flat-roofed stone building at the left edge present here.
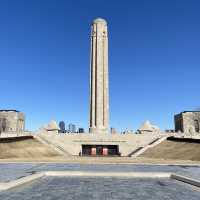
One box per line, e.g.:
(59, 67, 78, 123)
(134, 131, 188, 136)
(0, 110, 25, 132)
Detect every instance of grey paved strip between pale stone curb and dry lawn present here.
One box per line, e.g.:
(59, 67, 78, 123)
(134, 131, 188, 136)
(0, 163, 200, 182)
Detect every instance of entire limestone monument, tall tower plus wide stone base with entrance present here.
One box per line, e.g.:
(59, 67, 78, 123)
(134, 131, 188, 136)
(37, 18, 172, 156)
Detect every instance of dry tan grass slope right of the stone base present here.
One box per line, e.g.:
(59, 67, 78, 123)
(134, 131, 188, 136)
(140, 140, 200, 161)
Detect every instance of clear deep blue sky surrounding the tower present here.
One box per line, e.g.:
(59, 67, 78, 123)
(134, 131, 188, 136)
(0, 0, 200, 130)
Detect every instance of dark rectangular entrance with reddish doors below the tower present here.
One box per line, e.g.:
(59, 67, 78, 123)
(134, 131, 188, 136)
(82, 145, 120, 156)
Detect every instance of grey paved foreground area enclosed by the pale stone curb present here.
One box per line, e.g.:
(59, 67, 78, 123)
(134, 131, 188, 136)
(0, 177, 200, 200)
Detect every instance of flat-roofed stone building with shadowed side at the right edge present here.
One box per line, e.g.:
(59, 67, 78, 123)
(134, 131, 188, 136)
(174, 111, 200, 133)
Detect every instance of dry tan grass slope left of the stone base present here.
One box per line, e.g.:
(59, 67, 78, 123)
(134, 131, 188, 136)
(0, 138, 59, 159)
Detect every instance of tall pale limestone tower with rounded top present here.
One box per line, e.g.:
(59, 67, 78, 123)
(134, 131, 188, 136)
(89, 18, 109, 134)
